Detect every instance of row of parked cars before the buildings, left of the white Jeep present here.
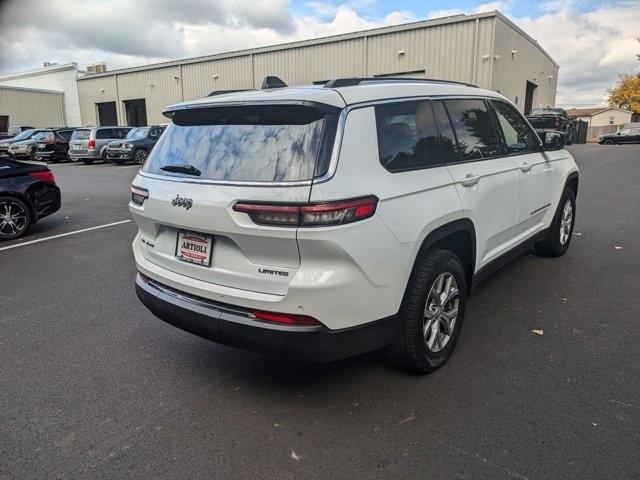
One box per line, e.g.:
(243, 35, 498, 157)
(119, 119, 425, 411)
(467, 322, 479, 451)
(0, 125, 166, 165)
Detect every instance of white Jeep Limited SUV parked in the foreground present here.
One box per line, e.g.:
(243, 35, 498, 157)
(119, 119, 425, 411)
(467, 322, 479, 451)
(130, 79, 578, 372)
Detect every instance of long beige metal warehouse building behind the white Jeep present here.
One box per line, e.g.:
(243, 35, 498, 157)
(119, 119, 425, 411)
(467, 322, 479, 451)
(78, 12, 558, 126)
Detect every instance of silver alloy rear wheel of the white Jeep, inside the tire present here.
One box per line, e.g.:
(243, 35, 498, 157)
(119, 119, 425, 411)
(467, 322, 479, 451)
(422, 272, 460, 353)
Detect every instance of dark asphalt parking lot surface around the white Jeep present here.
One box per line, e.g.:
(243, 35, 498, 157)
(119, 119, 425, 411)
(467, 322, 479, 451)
(0, 145, 640, 479)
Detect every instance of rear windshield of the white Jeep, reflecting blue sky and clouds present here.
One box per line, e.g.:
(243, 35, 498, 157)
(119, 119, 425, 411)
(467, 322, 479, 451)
(144, 105, 337, 182)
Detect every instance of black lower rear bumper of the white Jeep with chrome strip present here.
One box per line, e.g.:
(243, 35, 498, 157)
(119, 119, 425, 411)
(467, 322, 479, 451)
(135, 275, 398, 362)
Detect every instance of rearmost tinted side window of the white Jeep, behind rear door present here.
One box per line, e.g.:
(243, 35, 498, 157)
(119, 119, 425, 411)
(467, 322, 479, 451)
(375, 101, 441, 172)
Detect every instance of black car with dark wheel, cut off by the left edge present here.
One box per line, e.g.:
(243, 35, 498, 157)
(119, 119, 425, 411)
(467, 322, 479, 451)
(0, 158, 60, 241)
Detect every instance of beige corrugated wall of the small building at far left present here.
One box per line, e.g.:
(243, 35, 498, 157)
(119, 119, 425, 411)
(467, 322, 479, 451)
(0, 87, 66, 128)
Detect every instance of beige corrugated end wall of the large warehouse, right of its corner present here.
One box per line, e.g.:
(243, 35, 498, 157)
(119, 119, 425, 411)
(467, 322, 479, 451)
(491, 17, 558, 111)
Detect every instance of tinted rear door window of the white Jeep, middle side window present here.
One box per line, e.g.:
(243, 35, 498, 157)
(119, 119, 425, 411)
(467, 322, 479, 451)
(445, 99, 500, 161)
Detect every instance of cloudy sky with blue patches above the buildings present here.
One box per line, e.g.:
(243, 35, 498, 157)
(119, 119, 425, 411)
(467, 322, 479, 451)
(0, 0, 640, 106)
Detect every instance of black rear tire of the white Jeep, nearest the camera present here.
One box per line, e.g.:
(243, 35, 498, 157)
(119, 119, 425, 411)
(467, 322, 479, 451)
(387, 250, 467, 373)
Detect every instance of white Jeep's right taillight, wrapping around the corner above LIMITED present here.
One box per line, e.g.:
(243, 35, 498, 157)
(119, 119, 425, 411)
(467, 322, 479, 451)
(233, 196, 378, 227)
